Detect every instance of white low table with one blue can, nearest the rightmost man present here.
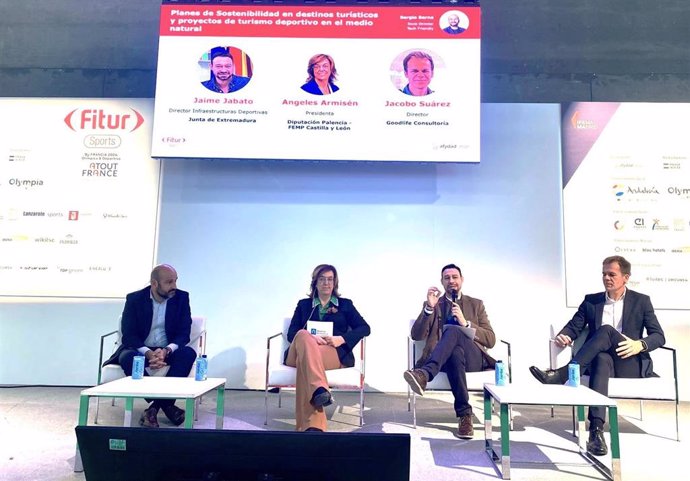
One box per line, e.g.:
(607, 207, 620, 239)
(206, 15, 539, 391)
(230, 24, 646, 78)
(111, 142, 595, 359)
(484, 384, 622, 481)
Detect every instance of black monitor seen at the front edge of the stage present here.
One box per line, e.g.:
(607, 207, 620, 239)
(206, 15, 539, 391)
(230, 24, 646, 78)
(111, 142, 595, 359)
(75, 426, 410, 481)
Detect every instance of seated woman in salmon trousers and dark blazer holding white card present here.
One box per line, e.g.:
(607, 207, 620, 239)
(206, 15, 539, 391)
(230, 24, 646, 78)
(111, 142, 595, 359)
(285, 264, 371, 431)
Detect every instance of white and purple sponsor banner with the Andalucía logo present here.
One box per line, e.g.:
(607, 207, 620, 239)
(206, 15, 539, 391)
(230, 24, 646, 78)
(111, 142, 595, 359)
(562, 103, 690, 309)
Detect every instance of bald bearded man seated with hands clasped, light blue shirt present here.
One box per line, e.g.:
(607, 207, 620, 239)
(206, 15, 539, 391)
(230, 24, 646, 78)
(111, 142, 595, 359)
(104, 264, 196, 427)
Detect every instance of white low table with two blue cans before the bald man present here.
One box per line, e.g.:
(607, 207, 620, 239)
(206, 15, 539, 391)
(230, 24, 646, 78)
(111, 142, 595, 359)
(74, 376, 225, 471)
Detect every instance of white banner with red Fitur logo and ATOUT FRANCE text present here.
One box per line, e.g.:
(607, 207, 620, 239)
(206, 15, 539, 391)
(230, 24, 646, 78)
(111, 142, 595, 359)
(0, 98, 160, 298)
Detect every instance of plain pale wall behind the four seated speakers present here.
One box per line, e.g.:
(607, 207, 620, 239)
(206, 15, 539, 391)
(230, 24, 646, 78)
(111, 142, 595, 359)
(0, 104, 690, 399)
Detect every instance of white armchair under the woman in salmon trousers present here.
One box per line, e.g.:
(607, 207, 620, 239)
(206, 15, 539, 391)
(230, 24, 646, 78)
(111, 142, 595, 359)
(264, 319, 366, 426)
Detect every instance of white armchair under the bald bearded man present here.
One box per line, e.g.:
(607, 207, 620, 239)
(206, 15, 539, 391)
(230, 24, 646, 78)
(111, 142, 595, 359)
(94, 316, 206, 423)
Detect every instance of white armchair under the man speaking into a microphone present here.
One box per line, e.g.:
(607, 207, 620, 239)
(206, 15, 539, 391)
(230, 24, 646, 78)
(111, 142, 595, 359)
(407, 319, 513, 428)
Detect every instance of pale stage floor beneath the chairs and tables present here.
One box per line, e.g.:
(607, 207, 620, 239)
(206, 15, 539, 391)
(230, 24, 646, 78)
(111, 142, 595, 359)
(0, 387, 690, 481)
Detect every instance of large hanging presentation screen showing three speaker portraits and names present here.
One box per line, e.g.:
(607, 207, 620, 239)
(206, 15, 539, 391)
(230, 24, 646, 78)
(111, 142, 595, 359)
(152, 1, 481, 162)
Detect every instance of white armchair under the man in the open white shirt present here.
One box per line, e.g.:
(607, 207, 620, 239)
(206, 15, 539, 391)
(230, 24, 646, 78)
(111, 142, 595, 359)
(549, 325, 680, 441)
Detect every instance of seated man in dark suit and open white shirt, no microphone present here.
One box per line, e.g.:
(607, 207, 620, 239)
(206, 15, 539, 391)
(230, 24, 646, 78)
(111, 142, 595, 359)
(530, 256, 666, 456)
